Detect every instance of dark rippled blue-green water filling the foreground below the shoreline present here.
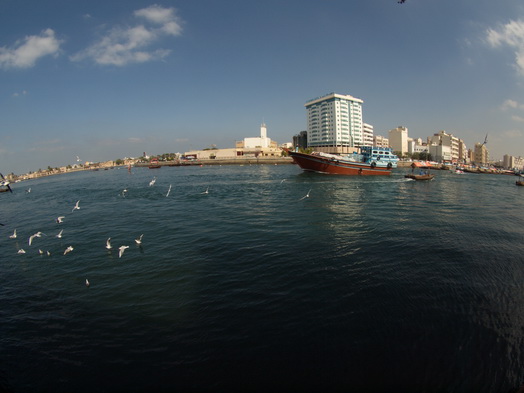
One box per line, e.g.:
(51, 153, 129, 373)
(0, 165, 524, 392)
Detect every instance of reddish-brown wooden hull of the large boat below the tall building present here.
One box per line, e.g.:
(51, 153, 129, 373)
(289, 151, 391, 176)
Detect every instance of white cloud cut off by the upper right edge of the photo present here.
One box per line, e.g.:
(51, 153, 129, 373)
(487, 20, 524, 76)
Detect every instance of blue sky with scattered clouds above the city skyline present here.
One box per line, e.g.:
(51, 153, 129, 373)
(0, 0, 524, 174)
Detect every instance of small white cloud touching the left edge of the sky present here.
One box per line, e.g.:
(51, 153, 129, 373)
(0, 29, 62, 69)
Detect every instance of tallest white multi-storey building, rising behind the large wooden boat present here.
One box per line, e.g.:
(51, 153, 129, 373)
(304, 93, 364, 153)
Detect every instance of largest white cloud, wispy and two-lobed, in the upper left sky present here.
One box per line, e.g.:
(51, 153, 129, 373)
(71, 5, 182, 66)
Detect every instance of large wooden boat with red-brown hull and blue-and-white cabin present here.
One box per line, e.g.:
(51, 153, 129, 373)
(284, 146, 398, 176)
